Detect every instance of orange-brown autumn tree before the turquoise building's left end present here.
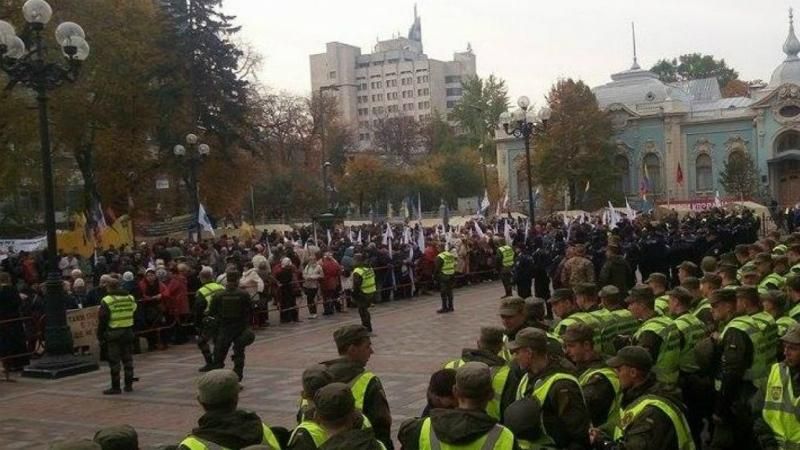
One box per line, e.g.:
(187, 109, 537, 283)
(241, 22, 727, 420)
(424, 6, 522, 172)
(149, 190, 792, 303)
(533, 78, 615, 209)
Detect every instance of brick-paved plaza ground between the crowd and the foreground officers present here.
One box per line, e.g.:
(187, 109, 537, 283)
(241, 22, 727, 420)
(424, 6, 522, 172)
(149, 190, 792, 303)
(0, 283, 502, 449)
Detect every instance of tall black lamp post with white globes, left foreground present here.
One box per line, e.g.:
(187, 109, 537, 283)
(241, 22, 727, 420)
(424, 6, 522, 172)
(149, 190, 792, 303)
(0, 0, 98, 378)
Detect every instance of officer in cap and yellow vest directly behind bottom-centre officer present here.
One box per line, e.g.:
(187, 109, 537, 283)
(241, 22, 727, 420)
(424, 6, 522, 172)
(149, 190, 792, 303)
(444, 327, 519, 422)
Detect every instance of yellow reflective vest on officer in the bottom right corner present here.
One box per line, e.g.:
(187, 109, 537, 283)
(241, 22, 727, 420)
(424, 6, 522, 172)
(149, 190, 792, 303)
(761, 363, 800, 450)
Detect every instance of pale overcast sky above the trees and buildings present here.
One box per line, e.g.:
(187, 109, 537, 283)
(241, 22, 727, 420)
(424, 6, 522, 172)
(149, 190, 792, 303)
(223, 0, 800, 105)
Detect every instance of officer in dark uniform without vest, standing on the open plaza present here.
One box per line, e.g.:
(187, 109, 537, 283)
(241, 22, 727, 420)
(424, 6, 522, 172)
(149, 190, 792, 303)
(208, 271, 255, 381)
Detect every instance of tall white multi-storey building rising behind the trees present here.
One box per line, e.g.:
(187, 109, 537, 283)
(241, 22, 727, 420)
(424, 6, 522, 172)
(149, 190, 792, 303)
(309, 7, 476, 149)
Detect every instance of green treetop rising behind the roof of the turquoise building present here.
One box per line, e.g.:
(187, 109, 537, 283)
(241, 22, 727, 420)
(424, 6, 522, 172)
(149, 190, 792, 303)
(650, 53, 739, 88)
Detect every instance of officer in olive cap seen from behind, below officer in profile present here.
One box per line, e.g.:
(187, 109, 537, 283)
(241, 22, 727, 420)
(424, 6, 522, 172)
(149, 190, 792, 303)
(314, 383, 386, 450)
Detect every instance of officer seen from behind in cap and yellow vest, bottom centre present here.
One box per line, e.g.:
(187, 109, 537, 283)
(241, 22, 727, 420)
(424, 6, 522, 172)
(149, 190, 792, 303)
(397, 362, 516, 450)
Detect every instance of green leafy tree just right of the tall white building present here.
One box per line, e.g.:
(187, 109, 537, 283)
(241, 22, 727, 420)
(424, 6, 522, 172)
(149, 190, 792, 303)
(450, 75, 509, 147)
